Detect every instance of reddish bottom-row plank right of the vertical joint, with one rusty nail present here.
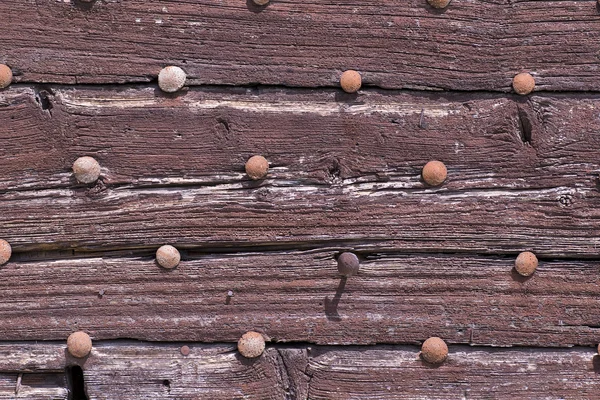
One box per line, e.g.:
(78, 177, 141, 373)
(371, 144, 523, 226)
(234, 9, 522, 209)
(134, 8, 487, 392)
(307, 346, 600, 400)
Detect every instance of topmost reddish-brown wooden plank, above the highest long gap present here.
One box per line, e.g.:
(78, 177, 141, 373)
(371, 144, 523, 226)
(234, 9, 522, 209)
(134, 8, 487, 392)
(0, 0, 600, 92)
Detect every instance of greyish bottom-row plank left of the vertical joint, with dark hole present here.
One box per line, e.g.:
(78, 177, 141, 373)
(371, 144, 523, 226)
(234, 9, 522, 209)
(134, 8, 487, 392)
(0, 341, 290, 400)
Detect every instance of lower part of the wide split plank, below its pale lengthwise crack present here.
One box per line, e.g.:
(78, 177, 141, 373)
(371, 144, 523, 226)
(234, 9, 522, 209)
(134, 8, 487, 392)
(0, 184, 600, 258)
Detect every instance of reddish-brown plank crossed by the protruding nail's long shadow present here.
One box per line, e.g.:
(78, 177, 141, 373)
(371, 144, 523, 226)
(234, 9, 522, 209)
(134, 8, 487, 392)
(0, 250, 600, 346)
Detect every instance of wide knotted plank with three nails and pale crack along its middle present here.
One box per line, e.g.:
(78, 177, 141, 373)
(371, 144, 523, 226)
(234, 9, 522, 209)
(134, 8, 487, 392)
(0, 88, 600, 258)
